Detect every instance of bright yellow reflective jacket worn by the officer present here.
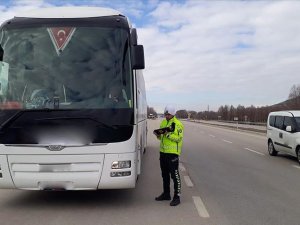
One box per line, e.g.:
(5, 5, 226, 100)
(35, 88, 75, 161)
(158, 116, 184, 155)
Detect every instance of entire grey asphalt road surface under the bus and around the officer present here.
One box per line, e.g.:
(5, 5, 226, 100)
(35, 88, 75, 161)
(0, 120, 300, 225)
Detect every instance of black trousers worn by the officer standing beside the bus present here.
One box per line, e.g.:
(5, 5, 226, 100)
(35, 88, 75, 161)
(160, 152, 181, 196)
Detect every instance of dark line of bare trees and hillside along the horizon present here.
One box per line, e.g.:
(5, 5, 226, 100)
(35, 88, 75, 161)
(148, 84, 300, 123)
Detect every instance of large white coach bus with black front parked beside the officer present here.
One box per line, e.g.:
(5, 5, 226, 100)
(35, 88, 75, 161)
(0, 7, 147, 190)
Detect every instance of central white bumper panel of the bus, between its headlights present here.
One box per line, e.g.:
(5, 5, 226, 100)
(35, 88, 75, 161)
(9, 155, 104, 190)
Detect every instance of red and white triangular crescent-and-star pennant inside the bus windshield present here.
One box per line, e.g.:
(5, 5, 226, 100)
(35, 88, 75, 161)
(47, 27, 76, 55)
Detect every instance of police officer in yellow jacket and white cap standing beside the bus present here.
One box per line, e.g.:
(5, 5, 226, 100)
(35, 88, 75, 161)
(155, 105, 183, 206)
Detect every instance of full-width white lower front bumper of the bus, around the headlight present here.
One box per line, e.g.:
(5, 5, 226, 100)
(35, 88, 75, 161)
(0, 153, 137, 190)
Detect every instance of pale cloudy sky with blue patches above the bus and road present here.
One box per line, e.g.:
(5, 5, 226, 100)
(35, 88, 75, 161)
(0, 0, 300, 112)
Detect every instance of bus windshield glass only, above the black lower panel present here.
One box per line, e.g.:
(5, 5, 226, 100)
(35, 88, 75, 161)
(0, 26, 133, 109)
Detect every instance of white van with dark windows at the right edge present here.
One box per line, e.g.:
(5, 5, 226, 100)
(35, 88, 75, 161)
(267, 111, 300, 163)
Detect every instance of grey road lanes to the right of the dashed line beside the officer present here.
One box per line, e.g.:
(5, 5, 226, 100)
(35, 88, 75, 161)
(181, 119, 300, 225)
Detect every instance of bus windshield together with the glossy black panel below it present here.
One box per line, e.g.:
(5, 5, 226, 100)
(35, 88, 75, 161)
(0, 25, 134, 145)
